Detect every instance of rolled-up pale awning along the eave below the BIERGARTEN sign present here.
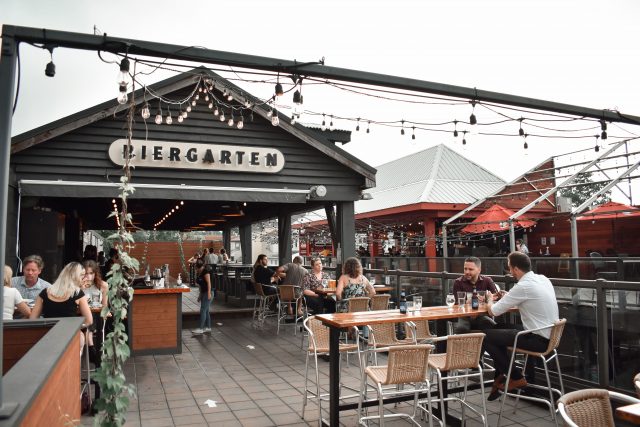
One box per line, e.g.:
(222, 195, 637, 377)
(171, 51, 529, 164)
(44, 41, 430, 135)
(18, 179, 311, 203)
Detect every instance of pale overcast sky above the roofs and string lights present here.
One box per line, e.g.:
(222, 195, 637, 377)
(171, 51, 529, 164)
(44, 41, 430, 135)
(0, 0, 640, 196)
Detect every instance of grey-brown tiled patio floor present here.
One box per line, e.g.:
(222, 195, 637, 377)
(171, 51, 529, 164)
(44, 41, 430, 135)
(81, 313, 562, 427)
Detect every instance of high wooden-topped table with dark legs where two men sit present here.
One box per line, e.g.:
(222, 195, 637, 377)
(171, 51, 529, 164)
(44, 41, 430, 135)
(316, 303, 496, 426)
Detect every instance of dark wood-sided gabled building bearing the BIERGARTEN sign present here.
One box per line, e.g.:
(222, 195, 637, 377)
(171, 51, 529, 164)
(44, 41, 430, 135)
(7, 69, 376, 279)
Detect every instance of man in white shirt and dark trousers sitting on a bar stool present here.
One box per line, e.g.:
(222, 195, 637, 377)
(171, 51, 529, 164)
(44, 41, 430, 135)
(484, 252, 558, 400)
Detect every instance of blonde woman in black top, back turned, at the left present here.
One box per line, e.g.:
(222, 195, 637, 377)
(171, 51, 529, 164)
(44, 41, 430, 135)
(29, 262, 93, 326)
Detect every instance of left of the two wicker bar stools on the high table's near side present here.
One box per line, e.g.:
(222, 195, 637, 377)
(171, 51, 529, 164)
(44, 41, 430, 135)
(358, 344, 433, 426)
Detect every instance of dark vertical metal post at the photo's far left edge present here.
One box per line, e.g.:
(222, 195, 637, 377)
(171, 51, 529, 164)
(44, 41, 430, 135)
(0, 36, 18, 419)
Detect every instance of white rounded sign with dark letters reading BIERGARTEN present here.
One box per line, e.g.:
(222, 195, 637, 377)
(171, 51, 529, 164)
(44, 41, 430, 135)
(109, 139, 284, 173)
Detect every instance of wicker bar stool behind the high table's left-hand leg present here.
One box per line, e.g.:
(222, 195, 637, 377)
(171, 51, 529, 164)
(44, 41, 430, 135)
(302, 316, 362, 425)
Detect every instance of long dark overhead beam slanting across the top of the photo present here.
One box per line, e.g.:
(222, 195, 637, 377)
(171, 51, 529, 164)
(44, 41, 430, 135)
(2, 25, 640, 124)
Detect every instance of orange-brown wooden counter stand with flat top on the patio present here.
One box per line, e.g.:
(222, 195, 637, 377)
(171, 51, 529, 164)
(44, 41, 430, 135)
(128, 287, 190, 356)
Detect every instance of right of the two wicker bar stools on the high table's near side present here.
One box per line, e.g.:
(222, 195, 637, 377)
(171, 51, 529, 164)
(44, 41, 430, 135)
(421, 333, 488, 426)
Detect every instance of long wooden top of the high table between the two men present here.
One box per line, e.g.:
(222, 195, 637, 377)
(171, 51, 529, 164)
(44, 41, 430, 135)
(316, 303, 487, 328)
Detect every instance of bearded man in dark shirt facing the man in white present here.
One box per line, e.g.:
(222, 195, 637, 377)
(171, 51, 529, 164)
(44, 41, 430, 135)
(453, 256, 498, 334)
